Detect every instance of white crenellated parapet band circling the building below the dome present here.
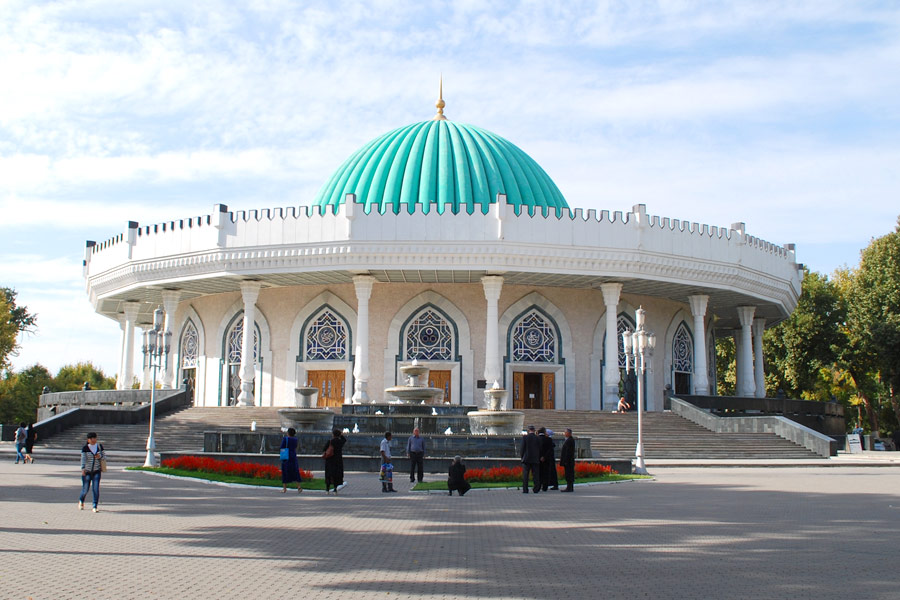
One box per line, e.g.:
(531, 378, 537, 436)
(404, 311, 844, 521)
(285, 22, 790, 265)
(84, 194, 801, 328)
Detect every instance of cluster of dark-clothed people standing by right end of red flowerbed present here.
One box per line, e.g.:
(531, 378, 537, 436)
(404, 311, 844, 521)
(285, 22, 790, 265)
(519, 425, 575, 494)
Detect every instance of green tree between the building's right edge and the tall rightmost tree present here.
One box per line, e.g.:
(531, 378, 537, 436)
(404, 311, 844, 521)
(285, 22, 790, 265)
(763, 272, 847, 401)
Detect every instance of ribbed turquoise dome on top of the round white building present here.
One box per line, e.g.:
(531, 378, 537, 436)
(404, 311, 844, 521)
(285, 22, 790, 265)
(313, 120, 568, 214)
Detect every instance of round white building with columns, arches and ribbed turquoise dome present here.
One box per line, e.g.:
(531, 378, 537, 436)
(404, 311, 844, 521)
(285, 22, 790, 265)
(84, 102, 801, 410)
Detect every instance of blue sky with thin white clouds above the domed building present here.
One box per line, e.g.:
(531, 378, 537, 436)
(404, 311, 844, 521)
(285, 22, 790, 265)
(0, 0, 900, 374)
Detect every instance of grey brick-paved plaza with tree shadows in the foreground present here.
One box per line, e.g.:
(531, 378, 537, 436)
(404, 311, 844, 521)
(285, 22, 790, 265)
(0, 460, 900, 600)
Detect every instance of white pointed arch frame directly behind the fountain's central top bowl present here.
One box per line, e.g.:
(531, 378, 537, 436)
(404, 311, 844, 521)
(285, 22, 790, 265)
(384, 290, 476, 405)
